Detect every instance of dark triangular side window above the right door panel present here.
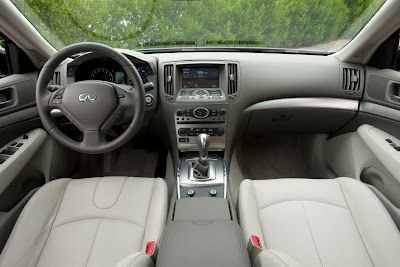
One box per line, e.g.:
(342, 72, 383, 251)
(368, 30, 400, 71)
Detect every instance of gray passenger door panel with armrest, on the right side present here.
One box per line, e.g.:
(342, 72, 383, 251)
(332, 67, 400, 229)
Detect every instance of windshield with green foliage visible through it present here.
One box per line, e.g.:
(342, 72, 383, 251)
(12, 0, 385, 52)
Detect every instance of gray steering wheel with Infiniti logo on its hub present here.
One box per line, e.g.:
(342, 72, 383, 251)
(36, 43, 145, 154)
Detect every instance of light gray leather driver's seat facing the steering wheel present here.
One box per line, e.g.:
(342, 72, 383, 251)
(0, 177, 167, 267)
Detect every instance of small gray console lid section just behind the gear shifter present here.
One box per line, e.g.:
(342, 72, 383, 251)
(174, 197, 231, 221)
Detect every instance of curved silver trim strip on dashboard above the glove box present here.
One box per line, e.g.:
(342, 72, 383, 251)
(244, 97, 359, 111)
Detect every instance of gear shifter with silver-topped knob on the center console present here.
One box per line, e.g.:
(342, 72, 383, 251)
(193, 133, 210, 179)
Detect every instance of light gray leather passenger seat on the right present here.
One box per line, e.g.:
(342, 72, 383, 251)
(239, 178, 400, 267)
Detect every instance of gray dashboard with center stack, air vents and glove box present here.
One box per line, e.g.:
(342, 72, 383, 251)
(57, 50, 365, 152)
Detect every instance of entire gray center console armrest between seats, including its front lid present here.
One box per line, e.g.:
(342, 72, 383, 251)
(156, 197, 250, 267)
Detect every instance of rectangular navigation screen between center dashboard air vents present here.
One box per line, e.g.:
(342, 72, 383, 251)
(182, 68, 219, 88)
